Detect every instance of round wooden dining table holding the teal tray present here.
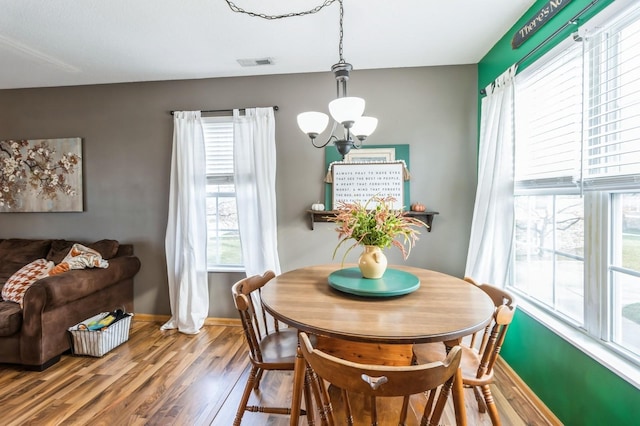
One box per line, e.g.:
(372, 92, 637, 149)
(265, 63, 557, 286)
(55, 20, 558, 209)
(261, 264, 495, 425)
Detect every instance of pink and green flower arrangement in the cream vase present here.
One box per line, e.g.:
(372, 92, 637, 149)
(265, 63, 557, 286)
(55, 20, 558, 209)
(329, 196, 428, 262)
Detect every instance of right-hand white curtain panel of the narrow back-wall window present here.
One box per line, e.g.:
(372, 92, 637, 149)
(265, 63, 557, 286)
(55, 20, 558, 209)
(233, 108, 280, 276)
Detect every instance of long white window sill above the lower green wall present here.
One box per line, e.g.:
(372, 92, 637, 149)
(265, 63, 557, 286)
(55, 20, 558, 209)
(518, 298, 640, 389)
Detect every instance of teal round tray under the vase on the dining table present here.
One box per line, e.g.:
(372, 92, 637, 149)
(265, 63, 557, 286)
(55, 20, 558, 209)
(329, 267, 420, 297)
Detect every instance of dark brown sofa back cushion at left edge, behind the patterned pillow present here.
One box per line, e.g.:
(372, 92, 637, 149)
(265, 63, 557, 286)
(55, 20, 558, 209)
(0, 238, 51, 286)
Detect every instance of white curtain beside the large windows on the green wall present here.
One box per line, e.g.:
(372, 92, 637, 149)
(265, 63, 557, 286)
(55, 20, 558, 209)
(465, 65, 516, 287)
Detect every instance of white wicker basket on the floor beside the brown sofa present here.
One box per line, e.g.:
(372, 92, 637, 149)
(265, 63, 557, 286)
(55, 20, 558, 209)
(69, 312, 133, 357)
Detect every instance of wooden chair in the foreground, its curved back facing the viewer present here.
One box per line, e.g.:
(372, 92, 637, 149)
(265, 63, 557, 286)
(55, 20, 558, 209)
(300, 333, 466, 426)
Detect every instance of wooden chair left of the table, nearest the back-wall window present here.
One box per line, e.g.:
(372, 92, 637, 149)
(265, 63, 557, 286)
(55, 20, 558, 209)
(231, 271, 313, 426)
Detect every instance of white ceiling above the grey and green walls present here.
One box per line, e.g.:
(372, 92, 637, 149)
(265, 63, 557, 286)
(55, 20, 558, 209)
(0, 0, 535, 89)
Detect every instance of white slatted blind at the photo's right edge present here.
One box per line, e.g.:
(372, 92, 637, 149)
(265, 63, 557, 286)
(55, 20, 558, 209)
(583, 8, 640, 190)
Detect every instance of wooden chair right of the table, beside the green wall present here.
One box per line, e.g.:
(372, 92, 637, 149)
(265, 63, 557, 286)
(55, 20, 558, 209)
(413, 277, 516, 425)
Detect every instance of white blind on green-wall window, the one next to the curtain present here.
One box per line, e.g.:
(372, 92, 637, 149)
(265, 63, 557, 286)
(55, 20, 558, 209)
(515, 41, 582, 190)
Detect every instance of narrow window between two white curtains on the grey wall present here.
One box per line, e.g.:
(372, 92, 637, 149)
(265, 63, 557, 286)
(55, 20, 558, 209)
(202, 117, 243, 271)
